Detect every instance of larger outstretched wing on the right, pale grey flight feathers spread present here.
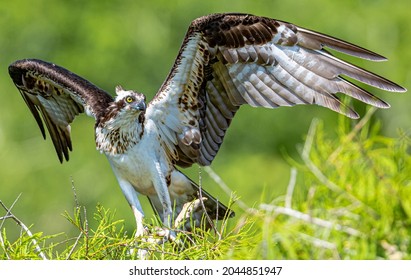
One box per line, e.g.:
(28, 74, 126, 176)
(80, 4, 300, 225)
(146, 14, 405, 166)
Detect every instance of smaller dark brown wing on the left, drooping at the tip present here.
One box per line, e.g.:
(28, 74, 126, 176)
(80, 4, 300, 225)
(9, 59, 113, 162)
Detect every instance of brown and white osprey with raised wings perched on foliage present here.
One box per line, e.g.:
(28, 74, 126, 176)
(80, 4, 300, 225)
(9, 14, 406, 236)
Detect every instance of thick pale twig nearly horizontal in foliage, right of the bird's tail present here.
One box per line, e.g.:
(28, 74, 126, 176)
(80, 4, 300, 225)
(260, 204, 362, 236)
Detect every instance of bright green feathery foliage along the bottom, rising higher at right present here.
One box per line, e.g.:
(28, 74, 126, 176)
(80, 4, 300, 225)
(0, 115, 411, 259)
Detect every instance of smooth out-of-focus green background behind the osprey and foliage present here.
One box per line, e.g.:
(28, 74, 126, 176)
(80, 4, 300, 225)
(0, 0, 411, 236)
